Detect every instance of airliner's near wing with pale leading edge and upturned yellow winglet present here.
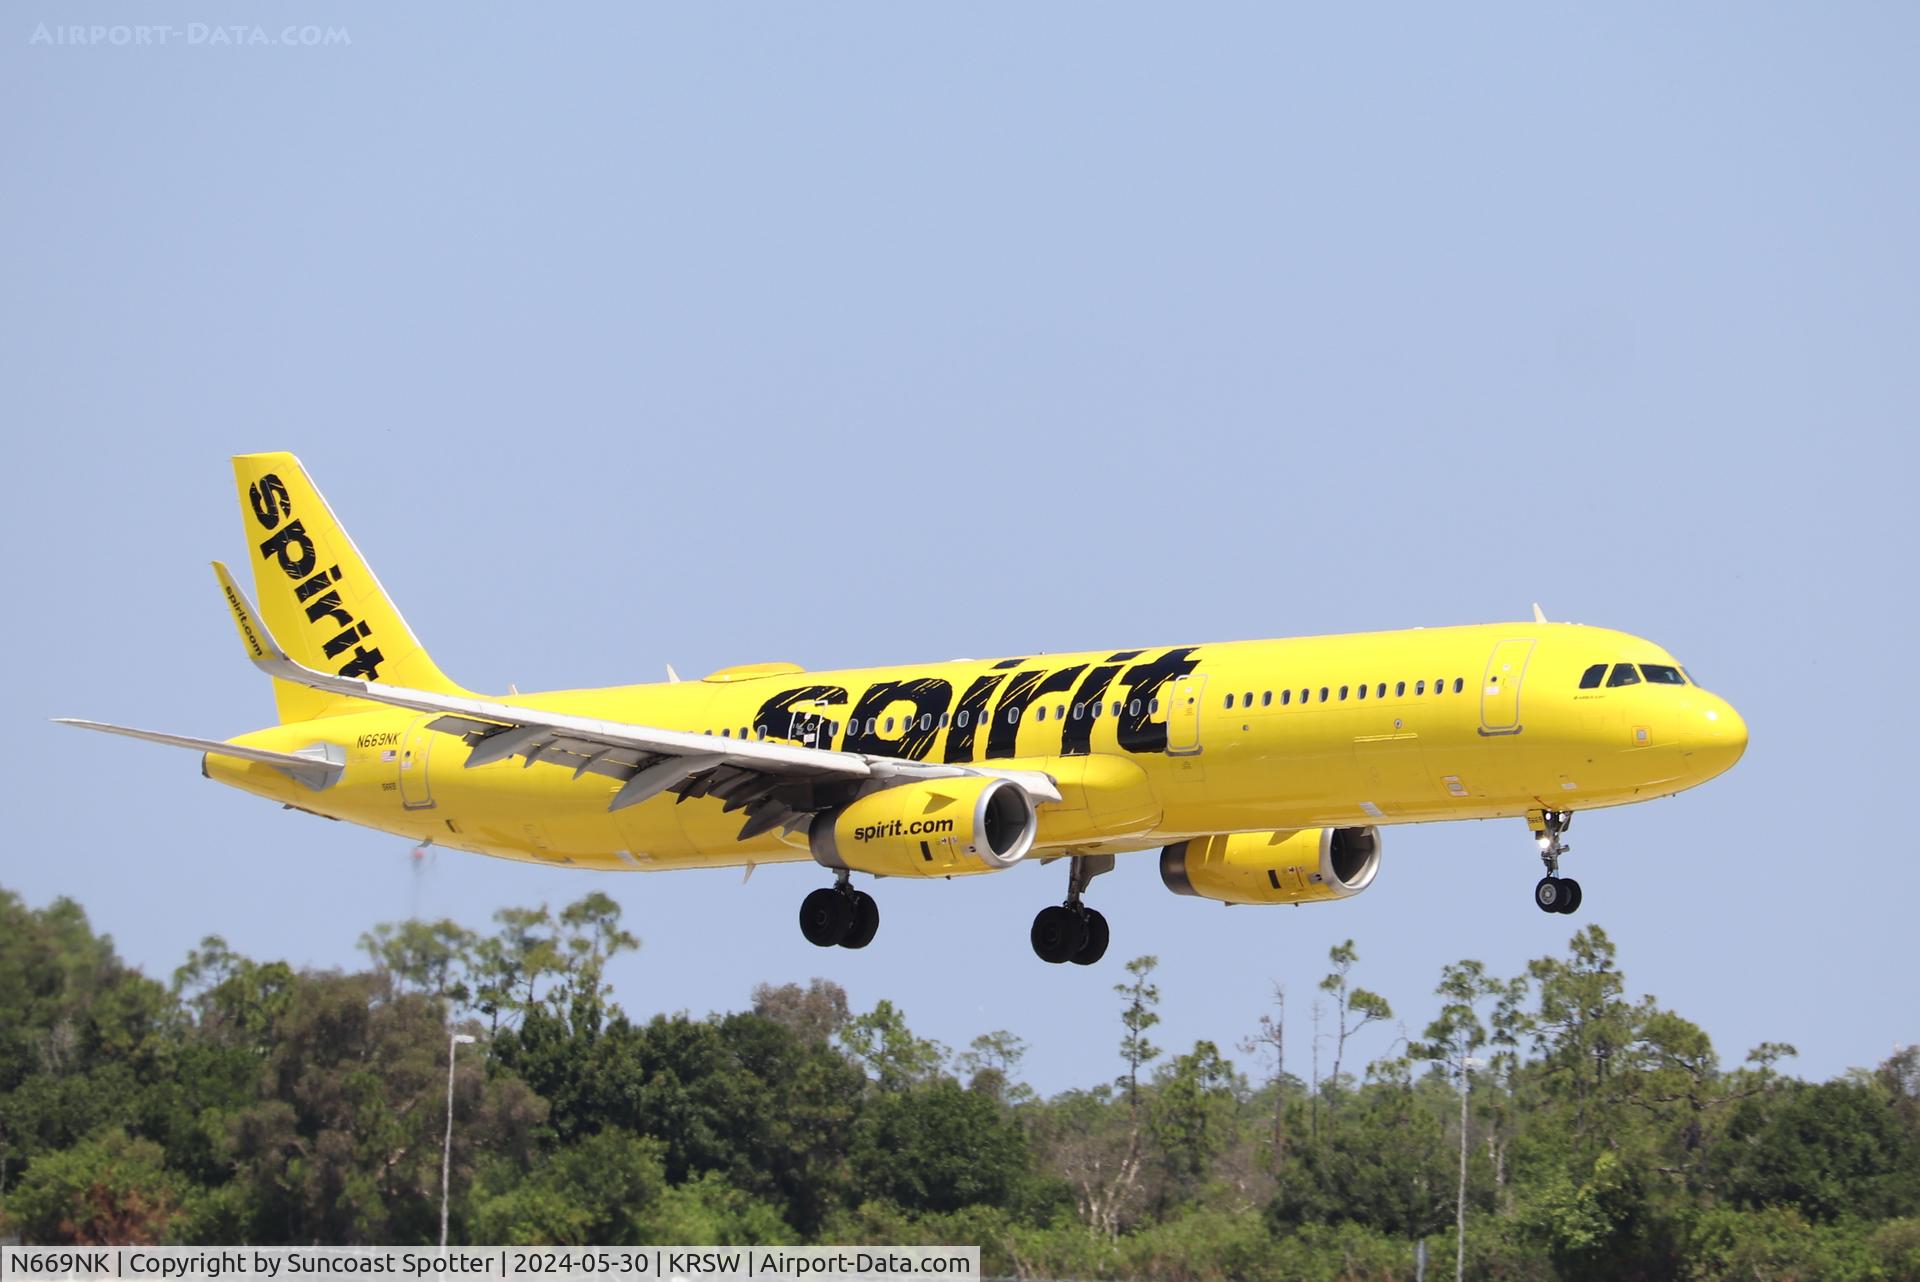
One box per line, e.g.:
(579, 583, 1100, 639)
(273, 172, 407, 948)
(213, 562, 1060, 841)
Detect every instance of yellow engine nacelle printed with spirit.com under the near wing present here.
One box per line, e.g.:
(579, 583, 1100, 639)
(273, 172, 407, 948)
(806, 775, 1041, 877)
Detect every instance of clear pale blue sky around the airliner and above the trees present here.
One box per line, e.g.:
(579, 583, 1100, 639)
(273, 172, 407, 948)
(0, 0, 1920, 1090)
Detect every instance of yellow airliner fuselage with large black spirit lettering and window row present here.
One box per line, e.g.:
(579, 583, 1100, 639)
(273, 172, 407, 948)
(205, 624, 1747, 869)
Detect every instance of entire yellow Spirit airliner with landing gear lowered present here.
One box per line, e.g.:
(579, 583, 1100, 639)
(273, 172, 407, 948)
(65, 453, 1747, 965)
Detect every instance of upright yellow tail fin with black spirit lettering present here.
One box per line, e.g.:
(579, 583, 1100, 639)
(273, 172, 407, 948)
(234, 453, 465, 724)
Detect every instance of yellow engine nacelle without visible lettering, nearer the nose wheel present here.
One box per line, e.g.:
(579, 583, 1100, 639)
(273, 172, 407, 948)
(1160, 827, 1380, 904)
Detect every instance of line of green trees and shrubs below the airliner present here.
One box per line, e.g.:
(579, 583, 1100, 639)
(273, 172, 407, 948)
(0, 890, 1920, 1282)
